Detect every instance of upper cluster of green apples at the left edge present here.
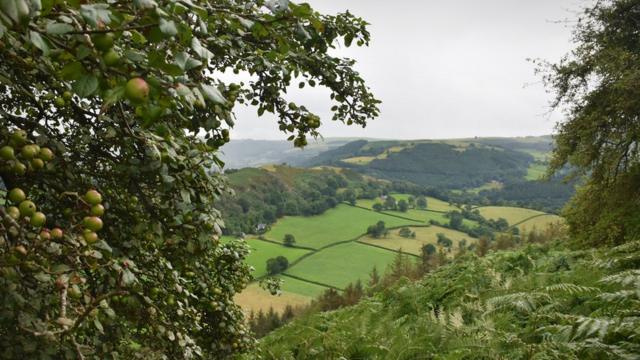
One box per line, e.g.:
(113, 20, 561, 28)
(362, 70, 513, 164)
(0, 130, 53, 175)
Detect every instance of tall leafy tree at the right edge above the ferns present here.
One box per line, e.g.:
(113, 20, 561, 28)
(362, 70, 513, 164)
(545, 0, 640, 244)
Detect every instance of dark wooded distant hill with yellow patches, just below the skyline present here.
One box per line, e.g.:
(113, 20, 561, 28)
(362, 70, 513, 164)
(306, 138, 549, 189)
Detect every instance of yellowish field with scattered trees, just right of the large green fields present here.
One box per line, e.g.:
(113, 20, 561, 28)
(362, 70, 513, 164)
(360, 226, 477, 256)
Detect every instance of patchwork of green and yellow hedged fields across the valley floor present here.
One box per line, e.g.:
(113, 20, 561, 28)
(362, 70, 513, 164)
(224, 180, 562, 312)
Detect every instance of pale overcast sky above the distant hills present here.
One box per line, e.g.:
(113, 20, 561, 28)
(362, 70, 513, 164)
(232, 0, 589, 139)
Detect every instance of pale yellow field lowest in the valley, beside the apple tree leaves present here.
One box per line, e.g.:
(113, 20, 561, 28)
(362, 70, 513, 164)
(234, 283, 311, 313)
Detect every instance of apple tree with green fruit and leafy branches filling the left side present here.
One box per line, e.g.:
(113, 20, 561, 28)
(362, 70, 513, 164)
(0, 0, 378, 358)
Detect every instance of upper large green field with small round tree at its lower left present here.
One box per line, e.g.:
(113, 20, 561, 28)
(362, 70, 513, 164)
(265, 204, 417, 249)
